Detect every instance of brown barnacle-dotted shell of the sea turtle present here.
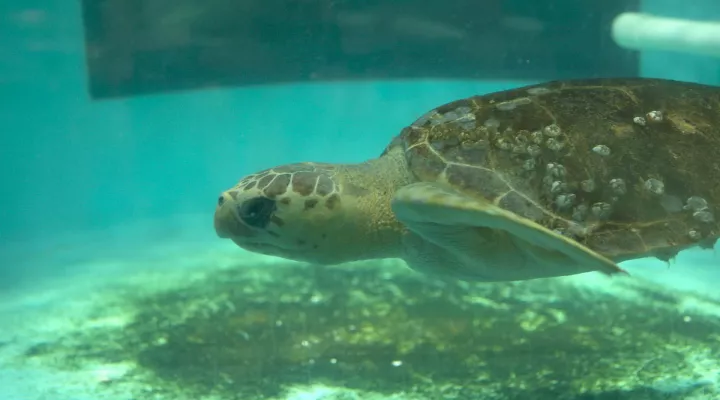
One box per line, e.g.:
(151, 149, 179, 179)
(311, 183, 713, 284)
(391, 78, 720, 261)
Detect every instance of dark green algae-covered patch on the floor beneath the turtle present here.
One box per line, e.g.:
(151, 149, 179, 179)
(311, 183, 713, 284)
(14, 262, 720, 400)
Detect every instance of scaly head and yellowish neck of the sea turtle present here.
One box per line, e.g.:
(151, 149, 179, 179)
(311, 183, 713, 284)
(215, 148, 412, 264)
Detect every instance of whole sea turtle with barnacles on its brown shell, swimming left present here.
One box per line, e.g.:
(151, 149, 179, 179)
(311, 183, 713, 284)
(214, 78, 720, 282)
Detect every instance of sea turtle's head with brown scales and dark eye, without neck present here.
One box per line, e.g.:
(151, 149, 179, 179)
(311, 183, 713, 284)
(215, 163, 344, 263)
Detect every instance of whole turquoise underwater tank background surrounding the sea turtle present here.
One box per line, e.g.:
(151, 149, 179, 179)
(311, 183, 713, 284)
(0, 0, 720, 400)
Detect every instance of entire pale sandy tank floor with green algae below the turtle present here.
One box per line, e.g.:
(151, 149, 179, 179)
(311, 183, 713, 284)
(0, 216, 720, 400)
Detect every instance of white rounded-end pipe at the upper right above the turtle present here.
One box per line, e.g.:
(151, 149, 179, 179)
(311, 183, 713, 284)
(612, 13, 720, 57)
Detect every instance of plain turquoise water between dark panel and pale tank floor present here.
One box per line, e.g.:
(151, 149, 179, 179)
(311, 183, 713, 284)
(0, 0, 720, 250)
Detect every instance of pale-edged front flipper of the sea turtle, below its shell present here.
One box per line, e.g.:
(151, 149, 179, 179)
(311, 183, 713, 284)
(392, 182, 623, 282)
